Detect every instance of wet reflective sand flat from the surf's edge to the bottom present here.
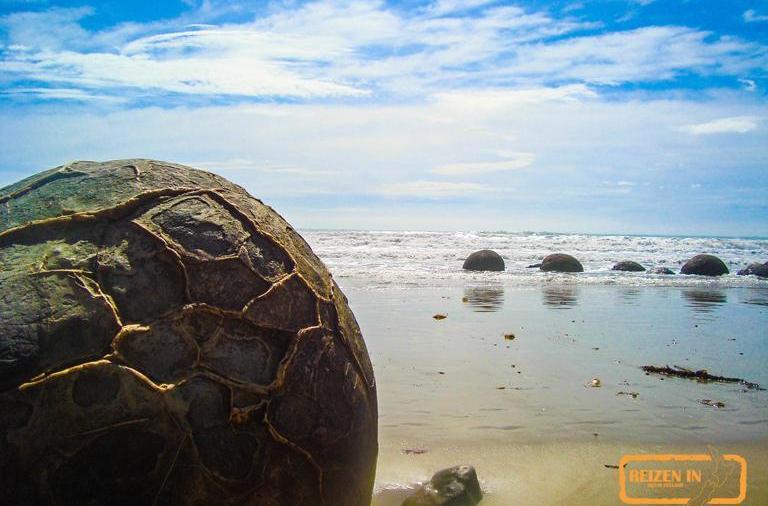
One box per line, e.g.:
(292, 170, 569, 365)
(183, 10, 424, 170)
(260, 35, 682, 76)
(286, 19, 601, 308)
(340, 278, 768, 506)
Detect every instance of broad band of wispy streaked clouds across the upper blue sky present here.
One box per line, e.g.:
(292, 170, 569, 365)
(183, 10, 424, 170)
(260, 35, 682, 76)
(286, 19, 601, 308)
(0, 0, 768, 101)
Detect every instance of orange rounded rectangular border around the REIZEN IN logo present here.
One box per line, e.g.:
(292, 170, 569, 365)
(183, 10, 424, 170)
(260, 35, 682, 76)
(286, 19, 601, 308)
(619, 453, 747, 504)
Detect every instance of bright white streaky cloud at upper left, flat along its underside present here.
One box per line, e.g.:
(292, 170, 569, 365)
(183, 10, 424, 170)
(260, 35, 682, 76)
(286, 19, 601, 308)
(5, 25, 367, 98)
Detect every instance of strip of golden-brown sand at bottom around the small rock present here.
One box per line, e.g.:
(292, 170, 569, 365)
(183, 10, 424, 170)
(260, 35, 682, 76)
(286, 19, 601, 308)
(372, 438, 768, 506)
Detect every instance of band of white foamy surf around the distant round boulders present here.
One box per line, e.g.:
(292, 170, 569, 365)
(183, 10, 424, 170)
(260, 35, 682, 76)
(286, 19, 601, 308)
(302, 230, 768, 288)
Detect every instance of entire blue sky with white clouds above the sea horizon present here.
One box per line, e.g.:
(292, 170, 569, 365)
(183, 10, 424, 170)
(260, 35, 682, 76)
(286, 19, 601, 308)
(0, 0, 768, 236)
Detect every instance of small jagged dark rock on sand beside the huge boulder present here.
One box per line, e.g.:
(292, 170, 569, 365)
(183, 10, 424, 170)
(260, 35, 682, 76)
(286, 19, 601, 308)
(402, 466, 483, 506)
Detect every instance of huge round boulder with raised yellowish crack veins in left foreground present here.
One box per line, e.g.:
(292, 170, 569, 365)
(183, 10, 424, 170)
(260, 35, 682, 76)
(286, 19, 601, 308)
(0, 159, 377, 506)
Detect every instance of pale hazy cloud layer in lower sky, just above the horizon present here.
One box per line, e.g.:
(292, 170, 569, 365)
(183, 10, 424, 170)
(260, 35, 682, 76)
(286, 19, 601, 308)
(0, 82, 768, 234)
